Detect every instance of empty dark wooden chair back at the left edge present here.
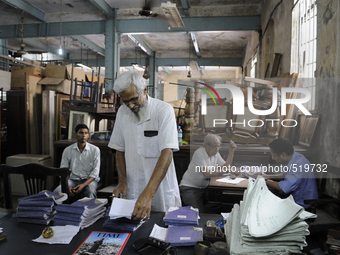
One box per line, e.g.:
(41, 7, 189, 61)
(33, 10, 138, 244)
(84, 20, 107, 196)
(0, 163, 70, 209)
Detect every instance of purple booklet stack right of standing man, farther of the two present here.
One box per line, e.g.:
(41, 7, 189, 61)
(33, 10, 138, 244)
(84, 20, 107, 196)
(164, 206, 199, 226)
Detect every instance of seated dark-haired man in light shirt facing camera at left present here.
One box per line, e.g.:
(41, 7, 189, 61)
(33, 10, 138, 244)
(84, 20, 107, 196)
(55, 124, 100, 198)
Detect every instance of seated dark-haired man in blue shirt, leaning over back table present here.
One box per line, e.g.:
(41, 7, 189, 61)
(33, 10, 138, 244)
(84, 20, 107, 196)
(263, 138, 318, 210)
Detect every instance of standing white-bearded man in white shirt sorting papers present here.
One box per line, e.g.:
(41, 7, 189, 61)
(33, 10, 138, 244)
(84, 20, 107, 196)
(109, 70, 181, 219)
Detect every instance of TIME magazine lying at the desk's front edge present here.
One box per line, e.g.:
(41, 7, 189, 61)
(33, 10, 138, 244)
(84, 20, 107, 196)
(72, 231, 131, 255)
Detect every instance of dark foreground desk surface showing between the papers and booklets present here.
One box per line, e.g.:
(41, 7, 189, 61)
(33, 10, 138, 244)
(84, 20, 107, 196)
(0, 213, 221, 255)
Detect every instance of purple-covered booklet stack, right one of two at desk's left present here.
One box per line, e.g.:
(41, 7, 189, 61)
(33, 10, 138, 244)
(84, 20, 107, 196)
(54, 197, 107, 229)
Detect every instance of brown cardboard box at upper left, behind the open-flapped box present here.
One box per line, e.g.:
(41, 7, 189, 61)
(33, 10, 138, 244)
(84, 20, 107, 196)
(11, 66, 42, 89)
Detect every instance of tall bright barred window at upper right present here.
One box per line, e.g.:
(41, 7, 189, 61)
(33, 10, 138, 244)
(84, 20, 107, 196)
(290, 0, 317, 110)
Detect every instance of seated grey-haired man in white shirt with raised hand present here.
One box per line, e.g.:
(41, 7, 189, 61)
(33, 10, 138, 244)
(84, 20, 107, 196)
(179, 134, 236, 213)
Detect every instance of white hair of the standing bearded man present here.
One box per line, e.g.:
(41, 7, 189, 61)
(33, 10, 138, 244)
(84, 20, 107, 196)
(113, 69, 146, 94)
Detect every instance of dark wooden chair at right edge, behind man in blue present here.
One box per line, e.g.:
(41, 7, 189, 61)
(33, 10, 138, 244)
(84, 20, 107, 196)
(304, 163, 340, 233)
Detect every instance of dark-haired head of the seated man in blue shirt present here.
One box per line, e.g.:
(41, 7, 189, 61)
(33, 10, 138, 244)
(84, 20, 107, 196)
(269, 138, 294, 164)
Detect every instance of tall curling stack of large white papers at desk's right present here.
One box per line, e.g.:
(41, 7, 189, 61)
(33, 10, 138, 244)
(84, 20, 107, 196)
(224, 176, 316, 255)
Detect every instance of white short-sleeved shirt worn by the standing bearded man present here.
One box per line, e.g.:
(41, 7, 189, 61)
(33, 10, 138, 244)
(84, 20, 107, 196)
(109, 97, 181, 212)
